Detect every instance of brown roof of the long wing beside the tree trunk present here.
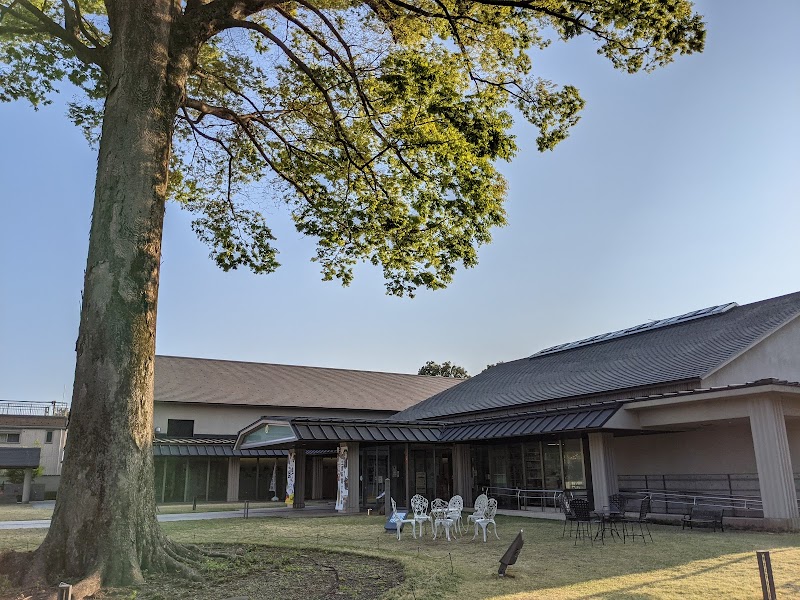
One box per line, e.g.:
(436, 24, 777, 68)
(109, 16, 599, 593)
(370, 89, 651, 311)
(155, 356, 462, 411)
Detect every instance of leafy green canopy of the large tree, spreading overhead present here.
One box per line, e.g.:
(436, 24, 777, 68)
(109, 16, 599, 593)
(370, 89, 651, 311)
(0, 0, 704, 295)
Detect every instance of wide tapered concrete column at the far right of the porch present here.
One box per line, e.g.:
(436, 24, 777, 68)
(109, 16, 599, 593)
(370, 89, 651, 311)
(748, 397, 800, 531)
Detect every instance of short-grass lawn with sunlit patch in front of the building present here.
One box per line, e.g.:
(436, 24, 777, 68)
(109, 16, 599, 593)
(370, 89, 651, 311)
(0, 516, 800, 600)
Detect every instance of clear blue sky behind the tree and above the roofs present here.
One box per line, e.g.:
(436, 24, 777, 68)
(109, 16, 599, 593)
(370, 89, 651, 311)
(0, 0, 800, 401)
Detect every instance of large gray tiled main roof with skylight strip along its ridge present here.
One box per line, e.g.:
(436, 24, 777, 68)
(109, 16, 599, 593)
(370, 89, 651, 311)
(392, 292, 800, 420)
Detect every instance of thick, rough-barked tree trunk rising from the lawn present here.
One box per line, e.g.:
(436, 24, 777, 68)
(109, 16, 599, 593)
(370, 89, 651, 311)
(33, 0, 195, 584)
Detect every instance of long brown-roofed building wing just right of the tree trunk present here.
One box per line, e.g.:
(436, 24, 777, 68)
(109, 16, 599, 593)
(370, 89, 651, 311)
(154, 356, 461, 502)
